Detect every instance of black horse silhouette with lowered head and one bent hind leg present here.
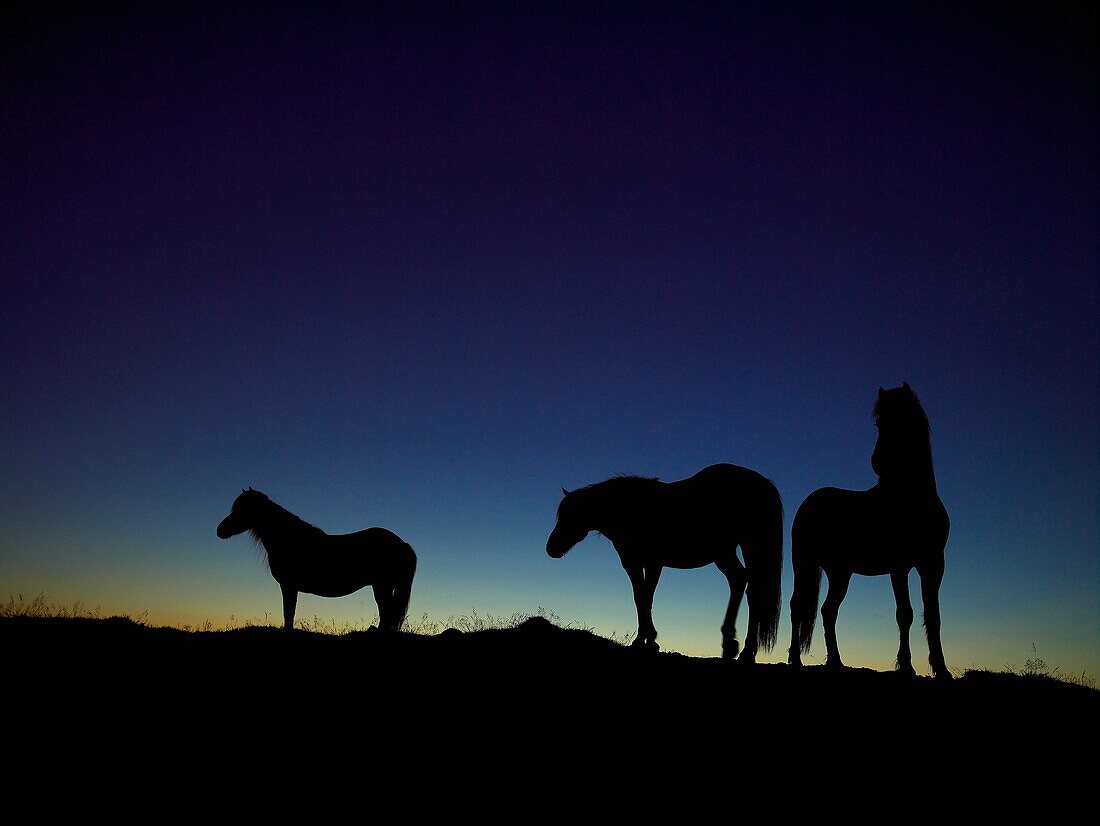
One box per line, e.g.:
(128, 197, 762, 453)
(547, 464, 783, 662)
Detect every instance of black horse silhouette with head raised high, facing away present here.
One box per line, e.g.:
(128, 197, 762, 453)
(788, 382, 952, 679)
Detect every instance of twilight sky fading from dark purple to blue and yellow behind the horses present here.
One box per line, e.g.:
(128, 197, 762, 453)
(0, 2, 1100, 674)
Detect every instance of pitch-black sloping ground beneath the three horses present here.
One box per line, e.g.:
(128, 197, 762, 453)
(0, 616, 1100, 809)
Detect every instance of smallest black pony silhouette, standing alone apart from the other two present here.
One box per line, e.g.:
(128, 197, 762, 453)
(218, 487, 416, 631)
